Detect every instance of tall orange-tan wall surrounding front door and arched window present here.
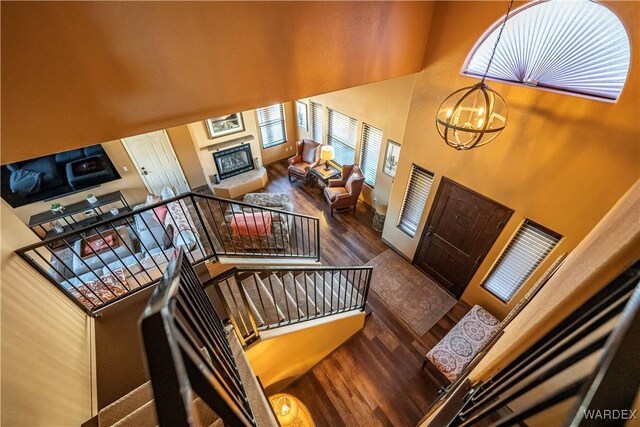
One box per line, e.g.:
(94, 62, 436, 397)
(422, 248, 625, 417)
(383, 2, 640, 316)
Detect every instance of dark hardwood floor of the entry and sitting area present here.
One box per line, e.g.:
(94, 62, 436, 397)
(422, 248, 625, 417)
(265, 163, 469, 427)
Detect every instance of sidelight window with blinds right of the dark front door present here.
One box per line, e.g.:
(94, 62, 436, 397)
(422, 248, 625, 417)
(483, 219, 562, 302)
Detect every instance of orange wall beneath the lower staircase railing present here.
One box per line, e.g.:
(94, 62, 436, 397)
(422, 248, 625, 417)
(246, 312, 364, 391)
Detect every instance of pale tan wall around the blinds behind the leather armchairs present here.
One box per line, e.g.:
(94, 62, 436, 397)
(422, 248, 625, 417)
(296, 74, 415, 209)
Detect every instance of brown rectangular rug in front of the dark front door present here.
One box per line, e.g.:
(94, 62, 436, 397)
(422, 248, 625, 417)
(367, 249, 456, 336)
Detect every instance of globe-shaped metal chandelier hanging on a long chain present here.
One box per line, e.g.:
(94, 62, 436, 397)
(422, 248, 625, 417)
(436, 0, 513, 150)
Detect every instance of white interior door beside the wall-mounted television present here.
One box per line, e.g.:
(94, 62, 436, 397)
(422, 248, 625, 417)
(122, 130, 189, 195)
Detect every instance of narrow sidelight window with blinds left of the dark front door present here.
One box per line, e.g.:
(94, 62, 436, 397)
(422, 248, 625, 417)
(398, 164, 433, 237)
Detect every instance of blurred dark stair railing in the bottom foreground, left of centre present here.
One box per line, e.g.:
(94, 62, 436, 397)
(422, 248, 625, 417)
(140, 249, 256, 426)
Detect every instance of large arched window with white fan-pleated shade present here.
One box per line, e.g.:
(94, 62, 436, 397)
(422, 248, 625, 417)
(464, 0, 631, 101)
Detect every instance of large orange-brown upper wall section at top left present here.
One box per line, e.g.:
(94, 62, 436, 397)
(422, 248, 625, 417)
(0, 1, 432, 163)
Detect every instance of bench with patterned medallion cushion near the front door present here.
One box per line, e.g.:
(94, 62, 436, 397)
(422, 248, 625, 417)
(423, 305, 500, 386)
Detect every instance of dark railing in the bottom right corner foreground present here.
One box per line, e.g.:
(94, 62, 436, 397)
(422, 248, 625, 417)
(420, 263, 640, 426)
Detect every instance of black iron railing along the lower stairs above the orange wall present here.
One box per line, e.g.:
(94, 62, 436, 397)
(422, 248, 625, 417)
(213, 266, 373, 345)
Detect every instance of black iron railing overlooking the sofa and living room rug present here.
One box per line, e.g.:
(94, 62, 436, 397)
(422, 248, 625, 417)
(16, 193, 320, 315)
